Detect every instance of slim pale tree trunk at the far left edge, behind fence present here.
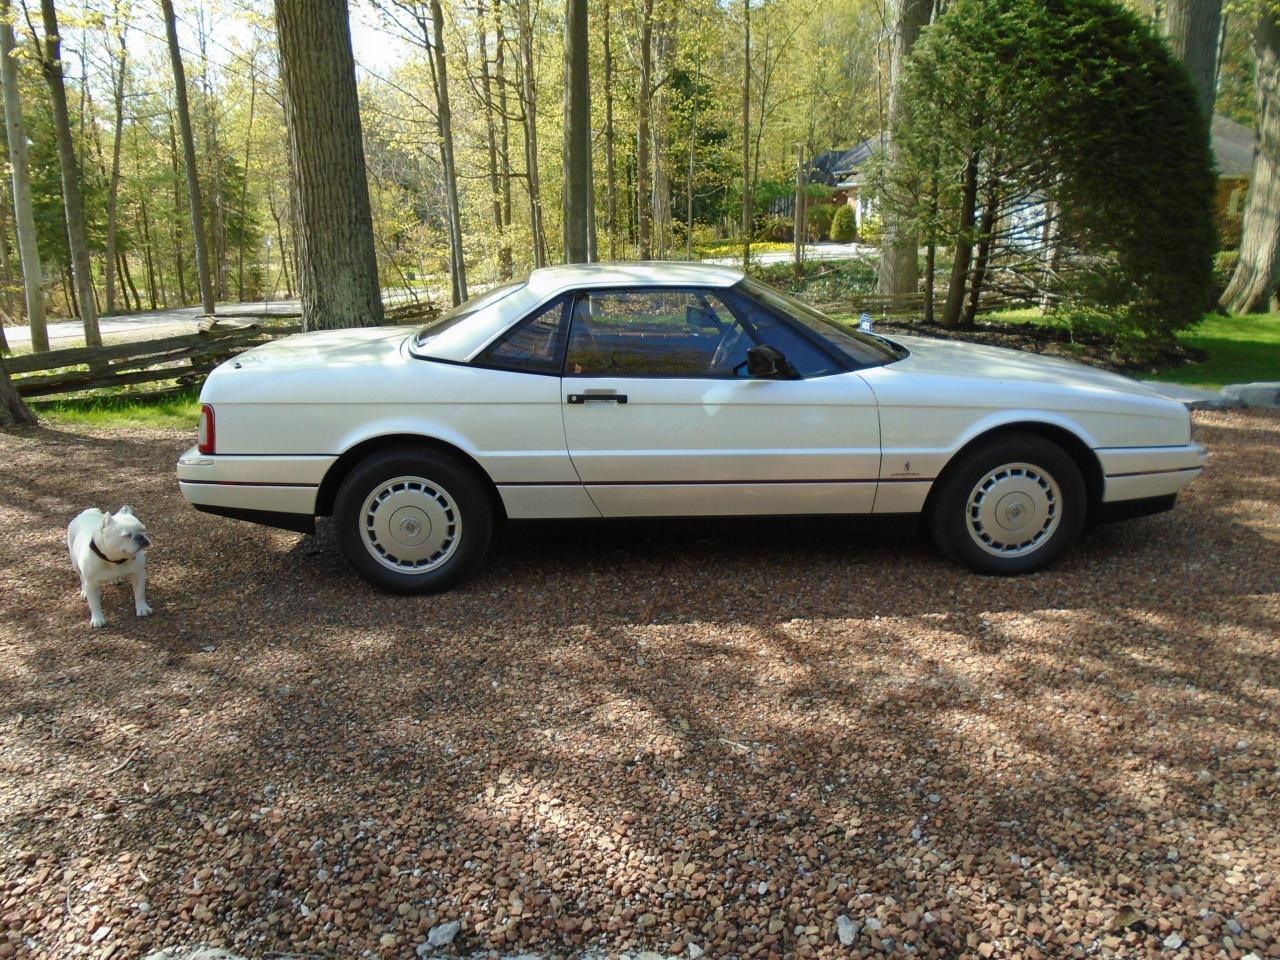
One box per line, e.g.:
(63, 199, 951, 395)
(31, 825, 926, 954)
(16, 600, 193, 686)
(0, 0, 49, 353)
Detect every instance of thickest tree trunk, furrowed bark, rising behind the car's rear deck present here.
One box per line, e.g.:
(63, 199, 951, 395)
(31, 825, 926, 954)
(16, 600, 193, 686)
(275, 0, 383, 330)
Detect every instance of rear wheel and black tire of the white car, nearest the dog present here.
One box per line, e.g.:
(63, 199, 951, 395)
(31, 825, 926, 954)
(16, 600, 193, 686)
(333, 447, 493, 594)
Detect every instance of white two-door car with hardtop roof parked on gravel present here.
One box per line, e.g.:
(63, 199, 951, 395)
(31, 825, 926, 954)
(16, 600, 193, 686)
(178, 264, 1206, 593)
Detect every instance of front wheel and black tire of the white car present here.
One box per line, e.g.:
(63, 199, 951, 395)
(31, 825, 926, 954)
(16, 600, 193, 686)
(929, 433, 1088, 576)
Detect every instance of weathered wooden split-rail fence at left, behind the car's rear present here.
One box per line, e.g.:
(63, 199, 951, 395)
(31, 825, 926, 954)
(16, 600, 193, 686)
(4, 303, 435, 399)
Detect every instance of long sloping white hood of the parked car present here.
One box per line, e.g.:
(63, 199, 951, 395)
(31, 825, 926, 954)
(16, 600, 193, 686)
(893, 337, 1161, 397)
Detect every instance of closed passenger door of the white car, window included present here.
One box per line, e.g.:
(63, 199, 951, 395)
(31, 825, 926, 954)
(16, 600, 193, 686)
(562, 288, 881, 517)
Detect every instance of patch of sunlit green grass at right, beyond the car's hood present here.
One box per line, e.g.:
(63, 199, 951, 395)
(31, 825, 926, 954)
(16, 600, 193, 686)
(1153, 314, 1280, 390)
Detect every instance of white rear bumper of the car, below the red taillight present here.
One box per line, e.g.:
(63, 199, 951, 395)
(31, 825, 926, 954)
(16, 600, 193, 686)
(178, 447, 337, 530)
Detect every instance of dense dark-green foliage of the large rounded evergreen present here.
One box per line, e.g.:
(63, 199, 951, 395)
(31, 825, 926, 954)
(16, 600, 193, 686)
(886, 0, 1215, 338)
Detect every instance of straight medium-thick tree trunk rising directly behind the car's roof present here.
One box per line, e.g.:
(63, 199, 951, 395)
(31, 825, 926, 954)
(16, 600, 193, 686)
(562, 0, 595, 264)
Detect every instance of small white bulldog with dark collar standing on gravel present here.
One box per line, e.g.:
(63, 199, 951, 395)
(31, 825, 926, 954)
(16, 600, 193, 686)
(67, 507, 151, 627)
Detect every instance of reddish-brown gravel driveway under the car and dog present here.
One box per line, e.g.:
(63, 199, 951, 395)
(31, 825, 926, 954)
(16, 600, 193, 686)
(0, 412, 1280, 959)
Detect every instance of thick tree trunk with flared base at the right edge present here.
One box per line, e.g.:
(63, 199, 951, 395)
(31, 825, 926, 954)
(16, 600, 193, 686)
(1222, 0, 1280, 314)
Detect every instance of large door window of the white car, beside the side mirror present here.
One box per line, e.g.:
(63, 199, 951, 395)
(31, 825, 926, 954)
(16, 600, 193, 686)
(564, 288, 753, 378)
